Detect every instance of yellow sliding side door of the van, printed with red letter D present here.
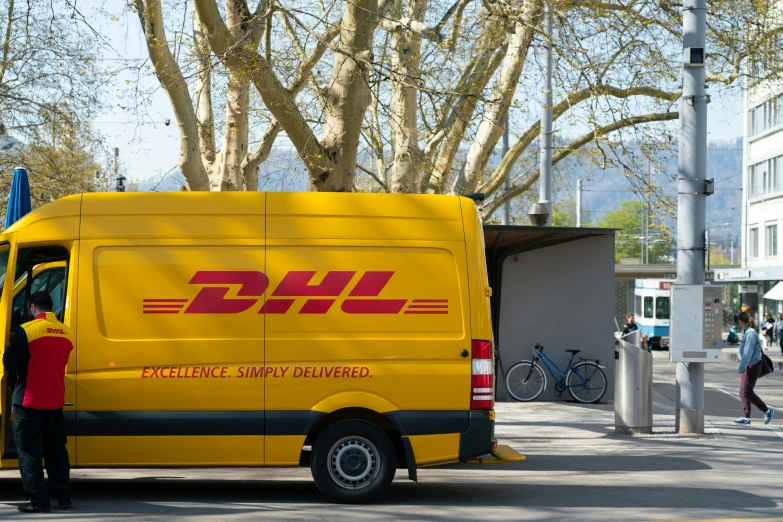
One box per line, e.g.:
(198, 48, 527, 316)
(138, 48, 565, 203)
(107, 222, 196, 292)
(76, 194, 268, 466)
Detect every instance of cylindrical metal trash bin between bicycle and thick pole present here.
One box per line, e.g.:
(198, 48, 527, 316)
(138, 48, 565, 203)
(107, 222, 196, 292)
(614, 331, 652, 434)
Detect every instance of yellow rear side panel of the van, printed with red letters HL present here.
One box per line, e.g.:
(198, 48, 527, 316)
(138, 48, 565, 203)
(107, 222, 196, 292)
(266, 193, 471, 461)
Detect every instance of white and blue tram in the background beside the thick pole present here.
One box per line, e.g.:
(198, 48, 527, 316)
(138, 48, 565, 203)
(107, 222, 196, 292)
(634, 279, 674, 348)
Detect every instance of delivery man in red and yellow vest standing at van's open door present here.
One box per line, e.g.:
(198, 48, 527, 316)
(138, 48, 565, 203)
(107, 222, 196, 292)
(3, 292, 73, 513)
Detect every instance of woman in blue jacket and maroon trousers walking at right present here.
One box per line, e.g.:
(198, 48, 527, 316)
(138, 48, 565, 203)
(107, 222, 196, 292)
(734, 312, 775, 426)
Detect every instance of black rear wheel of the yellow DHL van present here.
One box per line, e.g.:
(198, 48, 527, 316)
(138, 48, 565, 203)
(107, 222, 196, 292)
(310, 419, 397, 504)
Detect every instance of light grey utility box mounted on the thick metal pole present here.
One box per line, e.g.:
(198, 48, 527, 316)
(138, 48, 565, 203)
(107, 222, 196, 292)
(669, 285, 723, 362)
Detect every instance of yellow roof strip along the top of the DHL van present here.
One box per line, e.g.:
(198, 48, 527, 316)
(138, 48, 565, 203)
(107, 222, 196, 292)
(8, 192, 474, 240)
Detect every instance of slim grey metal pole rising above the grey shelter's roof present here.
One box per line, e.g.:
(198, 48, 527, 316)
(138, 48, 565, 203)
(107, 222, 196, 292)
(538, 0, 554, 226)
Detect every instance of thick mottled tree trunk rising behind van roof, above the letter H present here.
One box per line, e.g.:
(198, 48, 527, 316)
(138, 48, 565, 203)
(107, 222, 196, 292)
(316, 0, 378, 192)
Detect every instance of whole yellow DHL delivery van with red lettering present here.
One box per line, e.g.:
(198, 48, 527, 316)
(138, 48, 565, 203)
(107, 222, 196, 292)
(0, 193, 523, 502)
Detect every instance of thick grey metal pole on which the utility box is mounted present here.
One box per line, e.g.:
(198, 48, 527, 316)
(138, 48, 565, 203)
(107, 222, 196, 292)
(675, 0, 707, 434)
